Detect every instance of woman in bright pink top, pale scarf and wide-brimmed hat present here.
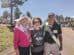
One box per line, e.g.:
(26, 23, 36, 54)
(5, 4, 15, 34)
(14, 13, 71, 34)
(13, 16, 31, 55)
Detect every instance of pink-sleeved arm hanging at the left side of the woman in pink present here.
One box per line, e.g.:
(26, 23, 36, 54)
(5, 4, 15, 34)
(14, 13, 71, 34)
(13, 29, 19, 55)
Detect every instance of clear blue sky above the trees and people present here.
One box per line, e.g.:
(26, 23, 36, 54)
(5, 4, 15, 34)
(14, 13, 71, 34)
(0, 0, 74, 19)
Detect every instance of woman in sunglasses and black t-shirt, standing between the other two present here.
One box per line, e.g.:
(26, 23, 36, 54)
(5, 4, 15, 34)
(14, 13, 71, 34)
(31, 17, 44, 55)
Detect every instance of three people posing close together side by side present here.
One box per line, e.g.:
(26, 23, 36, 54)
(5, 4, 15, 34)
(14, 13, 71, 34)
(13, 12, 62, 55)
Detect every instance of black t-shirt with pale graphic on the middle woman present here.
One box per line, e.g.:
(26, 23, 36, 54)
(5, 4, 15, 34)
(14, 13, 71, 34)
(32, 30, 44, 46)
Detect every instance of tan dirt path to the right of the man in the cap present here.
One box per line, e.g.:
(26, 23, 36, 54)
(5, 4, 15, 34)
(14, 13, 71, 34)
(63, 28, 74, 55)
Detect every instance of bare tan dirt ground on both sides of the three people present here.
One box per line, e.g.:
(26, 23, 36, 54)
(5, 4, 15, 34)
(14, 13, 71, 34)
(0, 28, 74, 55)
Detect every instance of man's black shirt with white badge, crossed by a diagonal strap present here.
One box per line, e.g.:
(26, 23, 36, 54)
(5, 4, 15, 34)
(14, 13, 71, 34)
(44, 22, 62, 44)
